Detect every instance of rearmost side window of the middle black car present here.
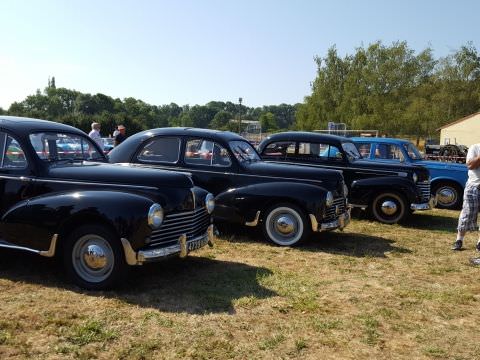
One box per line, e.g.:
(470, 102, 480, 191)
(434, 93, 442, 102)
(137, 137, 180, 163)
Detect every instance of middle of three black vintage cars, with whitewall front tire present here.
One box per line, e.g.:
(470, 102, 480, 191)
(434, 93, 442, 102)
(109, 128, 350, 246)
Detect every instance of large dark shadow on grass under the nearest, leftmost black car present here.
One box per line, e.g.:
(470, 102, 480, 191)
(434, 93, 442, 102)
(0, 249, 277, 314)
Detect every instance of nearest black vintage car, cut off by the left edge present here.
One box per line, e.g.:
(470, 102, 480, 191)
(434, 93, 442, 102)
(0, 116, 214, 289)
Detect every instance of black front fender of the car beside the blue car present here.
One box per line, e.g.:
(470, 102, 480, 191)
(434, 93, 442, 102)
(349, 176, 418, 205)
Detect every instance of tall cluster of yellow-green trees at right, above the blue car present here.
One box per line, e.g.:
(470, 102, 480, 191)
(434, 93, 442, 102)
(296, 42, 480, 137)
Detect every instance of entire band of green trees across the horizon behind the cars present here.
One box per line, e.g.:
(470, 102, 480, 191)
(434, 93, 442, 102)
(0, 42, 480, 137)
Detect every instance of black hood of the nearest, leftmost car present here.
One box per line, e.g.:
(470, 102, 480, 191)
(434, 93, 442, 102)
(48, 162, 193, 188)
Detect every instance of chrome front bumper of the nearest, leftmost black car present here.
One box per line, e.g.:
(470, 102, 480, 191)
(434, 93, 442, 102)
(122, 225, 214, 265)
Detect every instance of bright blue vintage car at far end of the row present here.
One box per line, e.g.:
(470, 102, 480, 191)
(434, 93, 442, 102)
(351, 137, 468, 209)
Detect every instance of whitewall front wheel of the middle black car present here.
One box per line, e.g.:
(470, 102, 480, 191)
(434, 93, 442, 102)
(262, 204, 312, 246)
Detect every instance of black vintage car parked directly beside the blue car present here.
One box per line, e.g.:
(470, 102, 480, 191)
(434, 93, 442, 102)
(258, 131, 434, 224)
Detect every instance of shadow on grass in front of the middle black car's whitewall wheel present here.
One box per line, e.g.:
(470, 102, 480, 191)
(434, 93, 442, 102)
(298, 231, 412, 258)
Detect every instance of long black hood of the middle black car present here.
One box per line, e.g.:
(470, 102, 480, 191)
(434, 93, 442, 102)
(244, 161, 343, 183)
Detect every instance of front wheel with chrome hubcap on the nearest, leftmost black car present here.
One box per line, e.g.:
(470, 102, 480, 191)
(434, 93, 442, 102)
(63, 225, 128, 290)
